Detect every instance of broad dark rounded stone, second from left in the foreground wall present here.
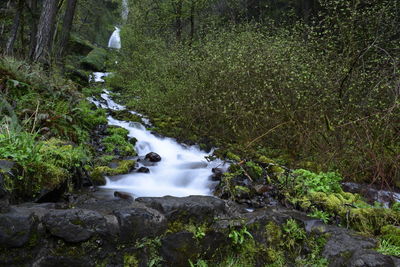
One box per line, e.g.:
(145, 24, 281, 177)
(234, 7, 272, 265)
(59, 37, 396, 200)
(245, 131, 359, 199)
(43, 209, 107, 243)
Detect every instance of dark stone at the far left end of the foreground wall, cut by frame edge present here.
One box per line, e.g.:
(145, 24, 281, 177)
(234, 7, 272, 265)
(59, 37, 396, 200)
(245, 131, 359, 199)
(0, 211, 36, 247)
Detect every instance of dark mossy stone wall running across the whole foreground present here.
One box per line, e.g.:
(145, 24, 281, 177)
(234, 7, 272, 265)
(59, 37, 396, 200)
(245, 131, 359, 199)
(0, 194, 400, 266)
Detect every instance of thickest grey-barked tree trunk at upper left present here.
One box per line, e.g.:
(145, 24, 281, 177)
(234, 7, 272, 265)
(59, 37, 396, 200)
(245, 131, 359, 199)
(32, 0, 58, 63)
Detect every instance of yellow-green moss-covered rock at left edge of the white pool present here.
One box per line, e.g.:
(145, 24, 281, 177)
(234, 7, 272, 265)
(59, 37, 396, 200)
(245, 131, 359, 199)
(91, 160, 136, 185)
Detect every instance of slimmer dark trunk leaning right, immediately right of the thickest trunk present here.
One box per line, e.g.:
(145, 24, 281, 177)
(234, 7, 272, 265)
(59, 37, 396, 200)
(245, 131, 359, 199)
(57, 0, 77, 61)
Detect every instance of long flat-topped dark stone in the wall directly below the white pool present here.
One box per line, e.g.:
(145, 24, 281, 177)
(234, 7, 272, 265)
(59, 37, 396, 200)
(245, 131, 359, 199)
(136, 196, 226, 221)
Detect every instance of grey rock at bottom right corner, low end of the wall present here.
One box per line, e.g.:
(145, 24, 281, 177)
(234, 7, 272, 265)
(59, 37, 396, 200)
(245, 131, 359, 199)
(346, 250, 398, 267)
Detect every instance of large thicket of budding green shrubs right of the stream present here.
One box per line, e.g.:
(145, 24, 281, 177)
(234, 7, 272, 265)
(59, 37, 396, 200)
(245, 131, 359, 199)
(111, 0, 400, 188)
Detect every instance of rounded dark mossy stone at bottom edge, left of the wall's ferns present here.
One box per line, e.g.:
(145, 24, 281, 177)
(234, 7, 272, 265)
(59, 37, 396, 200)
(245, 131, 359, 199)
(160, 231, 200, 267)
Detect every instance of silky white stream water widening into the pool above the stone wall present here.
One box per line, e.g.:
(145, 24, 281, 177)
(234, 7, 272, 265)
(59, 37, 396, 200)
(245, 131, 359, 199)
(91, 91, 228, 197)
